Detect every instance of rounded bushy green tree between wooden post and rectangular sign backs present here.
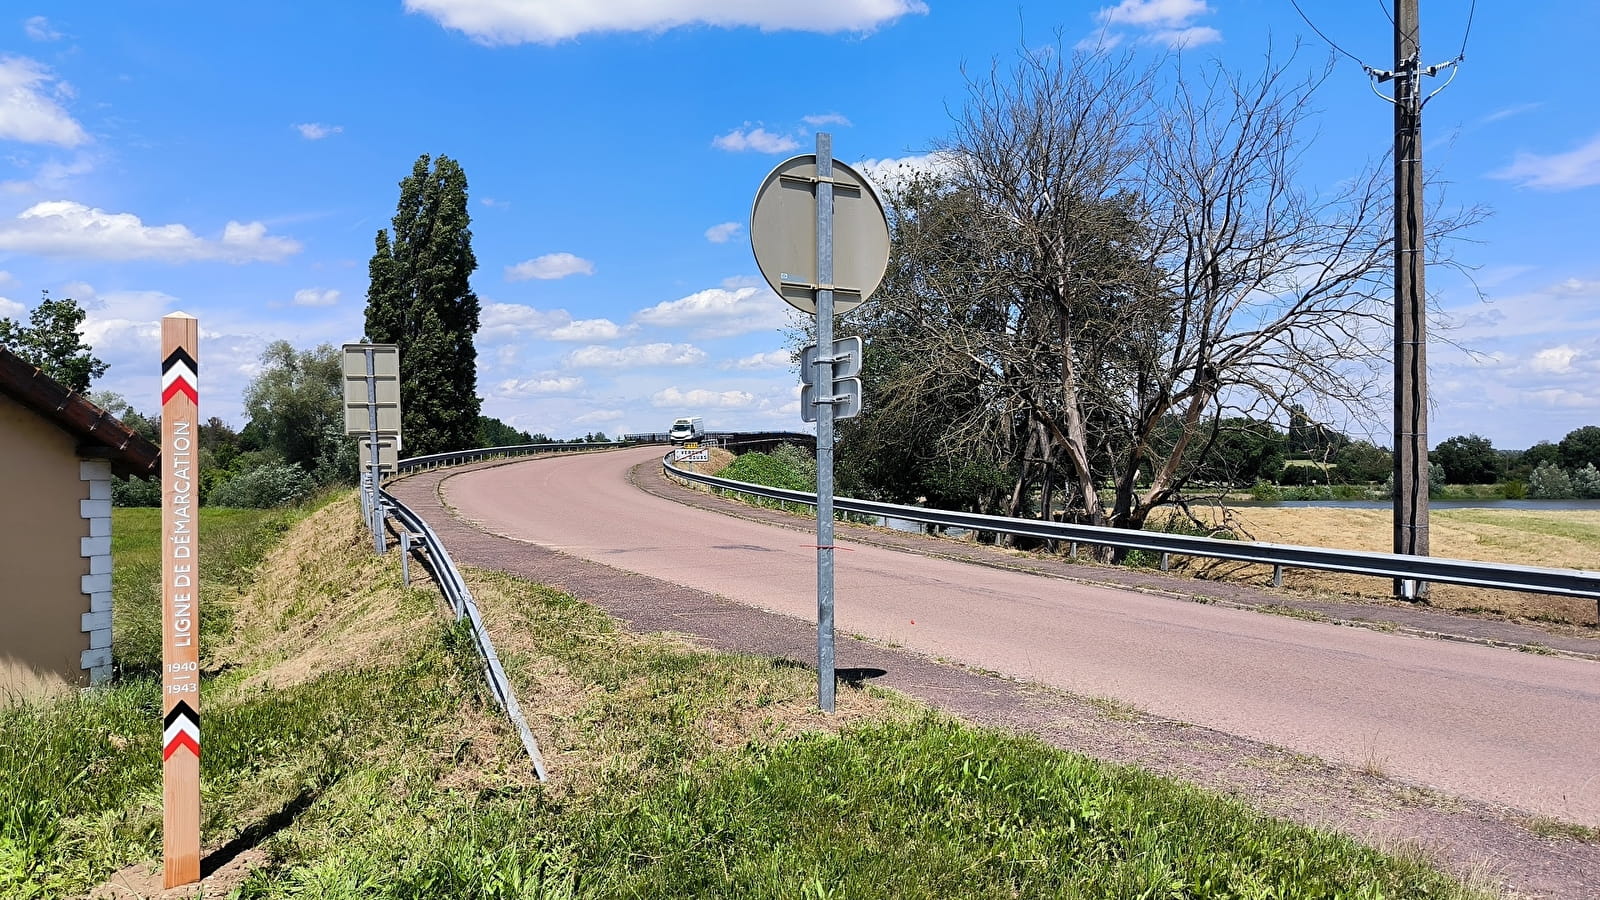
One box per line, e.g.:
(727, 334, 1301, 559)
(245, 341, 355, 484)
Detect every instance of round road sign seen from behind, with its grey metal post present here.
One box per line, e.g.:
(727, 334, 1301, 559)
(750, 133, 890, 713)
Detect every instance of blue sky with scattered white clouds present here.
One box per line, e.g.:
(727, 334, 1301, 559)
(0, 0, 1600, 448)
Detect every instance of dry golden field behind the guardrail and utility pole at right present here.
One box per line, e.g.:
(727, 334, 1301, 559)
(1190, 508, 1600, 625)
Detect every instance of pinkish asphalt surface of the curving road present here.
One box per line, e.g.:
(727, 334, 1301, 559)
(443, 448, 1600, 826)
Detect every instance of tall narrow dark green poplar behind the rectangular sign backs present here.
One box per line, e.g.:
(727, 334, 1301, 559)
(366, 154, 482, 455)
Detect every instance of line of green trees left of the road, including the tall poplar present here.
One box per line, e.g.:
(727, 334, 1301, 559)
(0, 154, 608, 506)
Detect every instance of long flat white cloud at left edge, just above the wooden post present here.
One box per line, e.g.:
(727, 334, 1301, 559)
(0, 200, 301, 263)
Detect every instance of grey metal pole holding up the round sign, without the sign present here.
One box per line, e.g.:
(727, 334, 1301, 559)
(814, 131, 834, 713)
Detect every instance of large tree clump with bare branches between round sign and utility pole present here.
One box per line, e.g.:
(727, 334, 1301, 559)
(845, 48, 1472, 528)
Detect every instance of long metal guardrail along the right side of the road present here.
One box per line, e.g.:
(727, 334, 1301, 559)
(661, 453, 1600, 601)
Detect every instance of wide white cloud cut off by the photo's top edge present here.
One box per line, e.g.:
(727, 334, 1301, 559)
(405, 0, 928, 45)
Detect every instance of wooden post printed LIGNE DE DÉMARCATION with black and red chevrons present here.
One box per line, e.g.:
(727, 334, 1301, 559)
(162, 312, 200, 887)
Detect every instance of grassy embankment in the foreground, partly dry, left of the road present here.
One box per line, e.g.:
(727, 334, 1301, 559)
(0, 496, 1482, 898)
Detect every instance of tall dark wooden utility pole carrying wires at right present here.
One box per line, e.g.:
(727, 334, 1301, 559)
(1378, 0, 1437, 602)
